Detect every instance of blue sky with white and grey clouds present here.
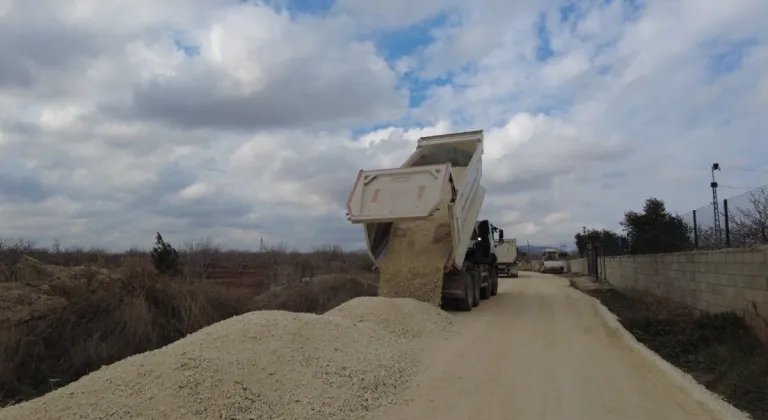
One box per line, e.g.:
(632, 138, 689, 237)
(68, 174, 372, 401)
(0, 0, 768, 251)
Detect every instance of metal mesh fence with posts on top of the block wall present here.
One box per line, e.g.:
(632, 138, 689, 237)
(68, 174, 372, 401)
(681, 185, 768, 249)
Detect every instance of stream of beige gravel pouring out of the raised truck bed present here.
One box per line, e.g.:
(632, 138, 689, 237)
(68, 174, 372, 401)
(379, 182, 453, 306)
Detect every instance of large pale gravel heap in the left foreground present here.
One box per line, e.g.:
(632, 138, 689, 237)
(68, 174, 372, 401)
(0, 309, 418, 420)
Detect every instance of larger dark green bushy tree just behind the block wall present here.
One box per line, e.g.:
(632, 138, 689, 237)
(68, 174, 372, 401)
(621, 198, 694, 254)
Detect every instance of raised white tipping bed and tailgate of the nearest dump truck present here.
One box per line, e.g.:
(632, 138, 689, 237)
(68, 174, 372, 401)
(347, 130, 485, 270)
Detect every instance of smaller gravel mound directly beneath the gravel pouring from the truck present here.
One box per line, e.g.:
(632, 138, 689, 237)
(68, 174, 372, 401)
(326, 297, 454, 339)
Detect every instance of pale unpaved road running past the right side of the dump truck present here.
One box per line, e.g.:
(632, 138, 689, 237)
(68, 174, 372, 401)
(371, 272, 746, 420)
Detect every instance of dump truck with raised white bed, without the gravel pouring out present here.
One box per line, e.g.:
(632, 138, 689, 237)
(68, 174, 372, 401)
(347, 130, 503, 311)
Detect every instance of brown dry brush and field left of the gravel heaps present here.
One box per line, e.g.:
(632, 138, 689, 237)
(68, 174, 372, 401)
(0, 236, 378, 406)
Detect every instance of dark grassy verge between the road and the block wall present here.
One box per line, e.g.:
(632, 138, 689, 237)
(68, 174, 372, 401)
(586, 288, 768, 420)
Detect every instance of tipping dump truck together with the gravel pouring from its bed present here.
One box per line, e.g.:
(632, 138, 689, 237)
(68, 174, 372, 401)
(347, 130, 498, 311)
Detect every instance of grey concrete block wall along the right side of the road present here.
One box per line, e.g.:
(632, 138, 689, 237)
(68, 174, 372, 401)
(571, 246, 768, 335)
